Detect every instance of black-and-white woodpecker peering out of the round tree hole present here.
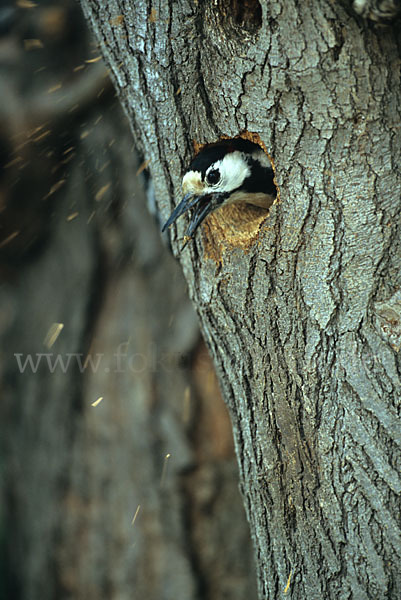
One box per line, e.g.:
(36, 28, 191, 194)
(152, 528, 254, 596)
(162, 138, 276, 248)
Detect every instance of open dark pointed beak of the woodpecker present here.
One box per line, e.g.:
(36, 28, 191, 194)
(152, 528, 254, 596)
(162, 193, 227, 241)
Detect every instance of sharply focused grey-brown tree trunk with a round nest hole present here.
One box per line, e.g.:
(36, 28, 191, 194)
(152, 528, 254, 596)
(81, 0, 401, 600)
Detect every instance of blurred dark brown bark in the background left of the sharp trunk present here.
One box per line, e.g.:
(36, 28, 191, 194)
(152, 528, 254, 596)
(0, 2, 256, 600)
